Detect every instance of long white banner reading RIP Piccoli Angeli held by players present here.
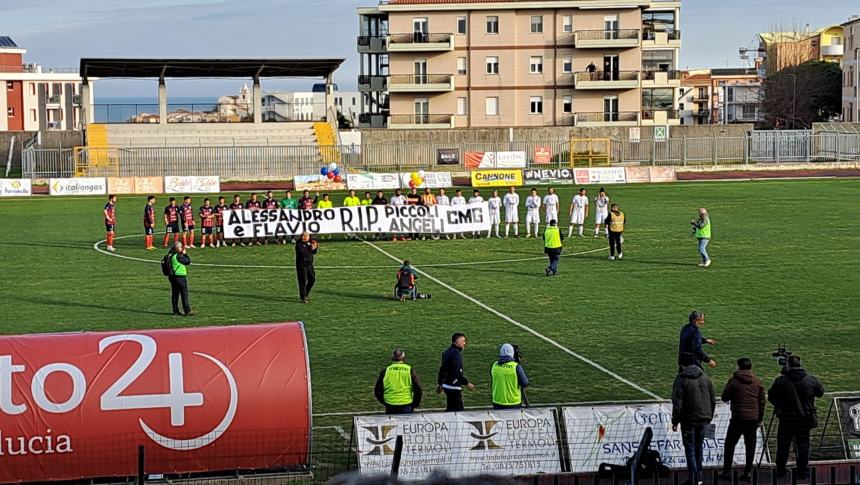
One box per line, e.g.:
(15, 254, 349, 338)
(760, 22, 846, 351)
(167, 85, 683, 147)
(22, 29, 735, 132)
(224, 203, 490, 239)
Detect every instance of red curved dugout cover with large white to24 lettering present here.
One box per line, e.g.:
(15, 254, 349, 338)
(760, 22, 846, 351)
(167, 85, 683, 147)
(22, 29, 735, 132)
(0, 323, 311, 483)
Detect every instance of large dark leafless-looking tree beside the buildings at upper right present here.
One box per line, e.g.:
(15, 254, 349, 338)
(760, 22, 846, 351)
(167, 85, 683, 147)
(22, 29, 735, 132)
(763, 61, 842, 129)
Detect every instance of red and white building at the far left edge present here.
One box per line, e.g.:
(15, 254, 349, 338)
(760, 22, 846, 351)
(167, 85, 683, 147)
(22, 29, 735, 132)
(0, 36, 92, 131)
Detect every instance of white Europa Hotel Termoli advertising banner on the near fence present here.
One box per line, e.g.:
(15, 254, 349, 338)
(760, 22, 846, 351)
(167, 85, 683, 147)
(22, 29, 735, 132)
(355, 409, 561, 480)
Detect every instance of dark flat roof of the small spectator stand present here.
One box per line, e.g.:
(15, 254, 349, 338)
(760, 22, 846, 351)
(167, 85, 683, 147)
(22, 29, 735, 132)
(80, 58, 344, 78)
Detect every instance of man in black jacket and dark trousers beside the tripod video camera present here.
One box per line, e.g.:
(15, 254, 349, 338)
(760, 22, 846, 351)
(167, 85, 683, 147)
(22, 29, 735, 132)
(767, 355, 824, 480)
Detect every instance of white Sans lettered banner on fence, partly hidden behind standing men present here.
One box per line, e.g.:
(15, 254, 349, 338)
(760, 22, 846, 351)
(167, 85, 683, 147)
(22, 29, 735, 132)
(562, 403, 770, 473)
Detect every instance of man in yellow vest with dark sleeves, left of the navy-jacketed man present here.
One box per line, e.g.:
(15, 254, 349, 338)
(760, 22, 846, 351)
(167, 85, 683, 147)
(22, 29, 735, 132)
(373, 348, 423, 414)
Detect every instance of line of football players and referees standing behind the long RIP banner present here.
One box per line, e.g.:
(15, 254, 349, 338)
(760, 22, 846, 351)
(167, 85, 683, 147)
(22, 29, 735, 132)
(99, 187, 609, 251)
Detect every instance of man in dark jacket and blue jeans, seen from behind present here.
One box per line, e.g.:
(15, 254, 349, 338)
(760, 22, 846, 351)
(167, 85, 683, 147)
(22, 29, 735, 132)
(672, 365, 717, 485)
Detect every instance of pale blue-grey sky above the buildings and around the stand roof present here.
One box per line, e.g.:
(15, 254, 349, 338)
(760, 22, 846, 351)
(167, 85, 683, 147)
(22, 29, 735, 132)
(0, 0, 860, 97)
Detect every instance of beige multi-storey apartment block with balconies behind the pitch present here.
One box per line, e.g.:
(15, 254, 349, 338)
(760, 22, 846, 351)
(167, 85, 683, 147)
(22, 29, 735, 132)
(358, 0, 681, 129)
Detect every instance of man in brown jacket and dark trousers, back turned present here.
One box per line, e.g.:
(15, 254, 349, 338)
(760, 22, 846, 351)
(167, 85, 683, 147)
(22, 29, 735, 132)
(720, 357, 767, 482)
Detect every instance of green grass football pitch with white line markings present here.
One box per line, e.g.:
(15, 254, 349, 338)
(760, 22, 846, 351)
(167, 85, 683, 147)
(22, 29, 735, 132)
(0, 179, 860, 422)
